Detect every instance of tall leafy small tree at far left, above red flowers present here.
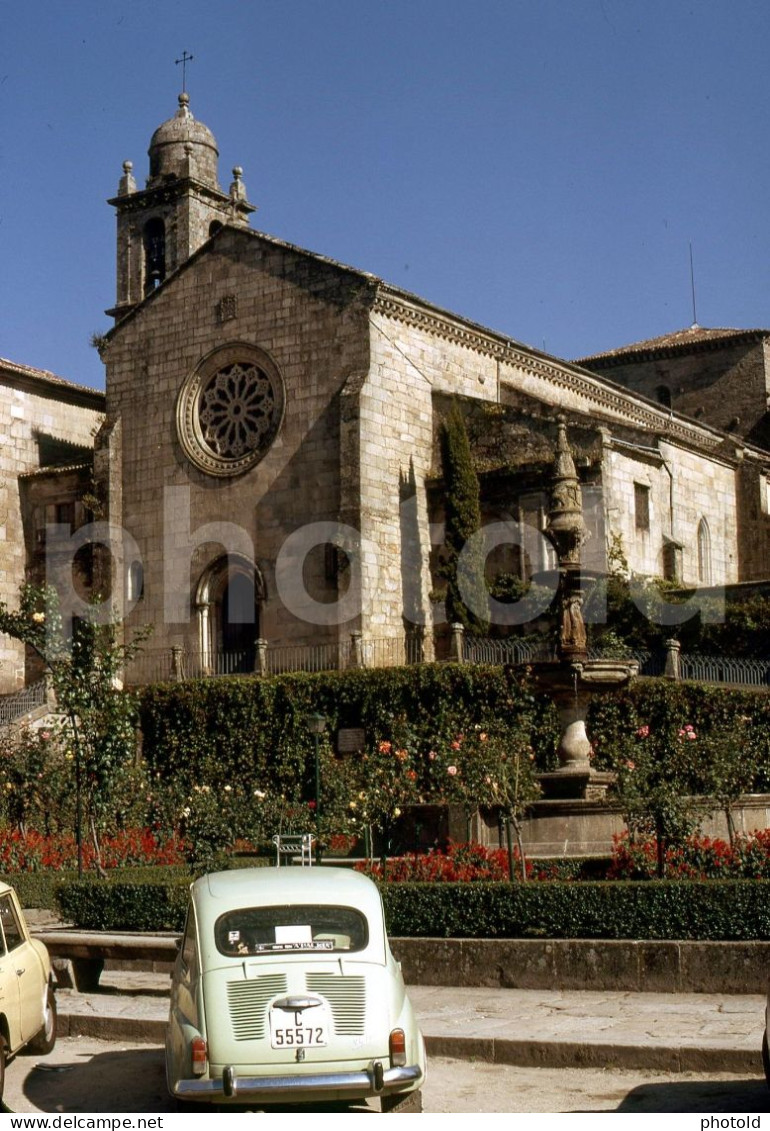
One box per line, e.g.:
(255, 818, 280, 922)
(0, 585, 148, 873)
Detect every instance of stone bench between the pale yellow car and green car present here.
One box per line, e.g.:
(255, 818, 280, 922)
(34, 930, 180, 993)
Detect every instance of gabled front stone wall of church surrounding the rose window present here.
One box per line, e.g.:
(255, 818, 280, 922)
(105, 228, 369, 665)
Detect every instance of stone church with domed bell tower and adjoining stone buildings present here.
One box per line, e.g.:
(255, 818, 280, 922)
(0, 94, 770, 691)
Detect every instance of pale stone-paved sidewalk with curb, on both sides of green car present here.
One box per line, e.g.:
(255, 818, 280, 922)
(58, 970, 764, 1074)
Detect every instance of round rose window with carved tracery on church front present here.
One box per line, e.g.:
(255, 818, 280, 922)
(176, 345, 284, 475)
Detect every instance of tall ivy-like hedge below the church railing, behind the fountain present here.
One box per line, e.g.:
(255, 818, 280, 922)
(140, 664, 770, 792)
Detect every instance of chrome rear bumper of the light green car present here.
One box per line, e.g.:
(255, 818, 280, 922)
(174, 1062, 423, 1103)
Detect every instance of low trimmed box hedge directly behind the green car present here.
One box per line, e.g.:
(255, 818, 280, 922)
(58, 878, 770, 941)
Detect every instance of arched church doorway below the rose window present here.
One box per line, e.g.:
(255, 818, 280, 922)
(196, 554, 266, 675)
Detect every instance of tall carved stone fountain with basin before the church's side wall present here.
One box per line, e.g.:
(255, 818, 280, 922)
(530, 416, 639, 809)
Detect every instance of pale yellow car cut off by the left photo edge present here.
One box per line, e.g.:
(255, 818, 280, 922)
(0, 882, 57, 1098)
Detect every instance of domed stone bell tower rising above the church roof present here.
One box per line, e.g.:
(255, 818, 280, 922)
(106, 93, 254, 321)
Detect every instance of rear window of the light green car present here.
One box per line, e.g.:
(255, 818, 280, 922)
(214, 904, 369, 958)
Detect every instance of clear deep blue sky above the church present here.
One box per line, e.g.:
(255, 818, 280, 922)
(0, 0, 770, 387)
